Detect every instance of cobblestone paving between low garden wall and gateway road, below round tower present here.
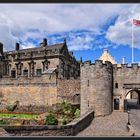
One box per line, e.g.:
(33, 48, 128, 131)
(77, 112, 132, 136)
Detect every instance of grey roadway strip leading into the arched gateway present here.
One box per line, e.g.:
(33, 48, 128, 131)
(129, 109, 140, 136)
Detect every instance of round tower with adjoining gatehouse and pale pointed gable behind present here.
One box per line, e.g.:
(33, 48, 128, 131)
(80, 50, 140, 116)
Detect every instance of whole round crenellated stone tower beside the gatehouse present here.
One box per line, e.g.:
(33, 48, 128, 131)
(81, 60, 113, 116)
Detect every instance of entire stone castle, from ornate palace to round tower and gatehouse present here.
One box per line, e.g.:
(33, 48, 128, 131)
(0, 39, 140, 116)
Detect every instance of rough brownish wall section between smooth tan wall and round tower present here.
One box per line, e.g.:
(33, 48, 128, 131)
(57, 79, 80, 104)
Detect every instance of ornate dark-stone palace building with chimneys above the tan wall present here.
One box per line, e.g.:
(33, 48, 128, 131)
(0, 39, 80, 79)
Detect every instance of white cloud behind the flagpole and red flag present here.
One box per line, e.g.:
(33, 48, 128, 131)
(106, 5, 140, 49)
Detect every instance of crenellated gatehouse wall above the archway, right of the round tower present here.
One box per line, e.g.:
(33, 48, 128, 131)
(113, 64, 140, 111)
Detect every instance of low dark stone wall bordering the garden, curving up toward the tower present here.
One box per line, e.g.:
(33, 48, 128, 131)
(1, 110, 94, 136)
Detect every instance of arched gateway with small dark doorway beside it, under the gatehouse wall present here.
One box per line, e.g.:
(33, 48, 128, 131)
(113, 83, 140, 111)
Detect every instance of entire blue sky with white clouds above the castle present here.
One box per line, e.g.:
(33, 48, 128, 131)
(0, 4, 140, 63)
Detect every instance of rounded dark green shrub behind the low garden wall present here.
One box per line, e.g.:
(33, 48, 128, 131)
(46, 114, 58, 125)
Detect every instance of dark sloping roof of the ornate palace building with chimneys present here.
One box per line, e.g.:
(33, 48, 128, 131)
(5, 43, 64, 53)
